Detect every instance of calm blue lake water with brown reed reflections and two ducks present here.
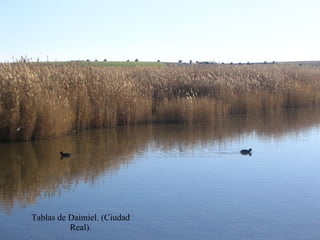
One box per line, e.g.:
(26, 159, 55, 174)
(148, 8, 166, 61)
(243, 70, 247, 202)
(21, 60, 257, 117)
(0, 111, 320, 240)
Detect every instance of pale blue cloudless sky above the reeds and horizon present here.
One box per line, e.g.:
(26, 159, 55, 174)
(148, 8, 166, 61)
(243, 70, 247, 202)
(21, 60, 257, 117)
(0, 0, 320, 62)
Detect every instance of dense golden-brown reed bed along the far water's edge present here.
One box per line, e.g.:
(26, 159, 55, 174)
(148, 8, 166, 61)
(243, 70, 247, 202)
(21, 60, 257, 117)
(0, 63, 320, 141)
